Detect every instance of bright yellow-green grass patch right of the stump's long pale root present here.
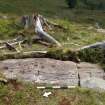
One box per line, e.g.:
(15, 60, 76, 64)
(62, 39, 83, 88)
(51, 19, 105, 48)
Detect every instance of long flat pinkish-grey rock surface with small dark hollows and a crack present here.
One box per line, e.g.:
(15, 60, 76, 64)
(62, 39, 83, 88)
(0, 58, 104, 86)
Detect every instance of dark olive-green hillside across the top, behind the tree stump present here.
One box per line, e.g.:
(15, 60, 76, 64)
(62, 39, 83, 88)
(0, 0, 105, 24)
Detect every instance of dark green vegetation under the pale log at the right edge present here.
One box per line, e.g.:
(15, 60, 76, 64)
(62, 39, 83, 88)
(78, 48, 105, 70)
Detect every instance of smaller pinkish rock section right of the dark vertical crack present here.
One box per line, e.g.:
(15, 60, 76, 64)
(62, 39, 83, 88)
(77, 62, 104, 79)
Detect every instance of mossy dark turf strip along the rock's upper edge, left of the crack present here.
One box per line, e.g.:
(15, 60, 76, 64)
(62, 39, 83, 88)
(0, 48, 79, 62)
